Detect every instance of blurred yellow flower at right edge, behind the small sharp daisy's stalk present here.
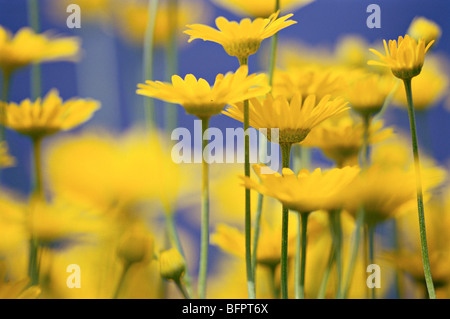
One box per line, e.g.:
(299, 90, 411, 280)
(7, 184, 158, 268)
(394, 56, 449, 111)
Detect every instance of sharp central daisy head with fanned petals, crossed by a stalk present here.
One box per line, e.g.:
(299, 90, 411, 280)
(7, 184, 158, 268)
(223, 94, 348, 144)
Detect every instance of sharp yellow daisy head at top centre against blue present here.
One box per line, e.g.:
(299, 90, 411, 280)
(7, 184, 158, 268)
(184, 11, 297, 60)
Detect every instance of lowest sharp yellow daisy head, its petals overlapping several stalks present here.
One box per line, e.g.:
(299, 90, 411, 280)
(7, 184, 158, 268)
(242, 164, 359, 213)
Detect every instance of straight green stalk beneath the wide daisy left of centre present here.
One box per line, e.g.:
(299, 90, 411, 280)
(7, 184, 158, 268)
(198, 117, 209, 299)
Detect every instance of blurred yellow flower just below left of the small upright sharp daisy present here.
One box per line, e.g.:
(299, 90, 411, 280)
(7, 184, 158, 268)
(345, 73, 394, 117)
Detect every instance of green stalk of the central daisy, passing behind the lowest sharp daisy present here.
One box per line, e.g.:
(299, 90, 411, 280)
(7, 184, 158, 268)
(280, 143, 292, 299)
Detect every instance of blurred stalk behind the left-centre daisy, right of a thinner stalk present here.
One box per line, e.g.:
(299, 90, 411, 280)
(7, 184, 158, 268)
(165, 0, 178, 134)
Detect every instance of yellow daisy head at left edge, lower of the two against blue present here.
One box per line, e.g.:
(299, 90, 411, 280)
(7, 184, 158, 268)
(1, 89, 100, 138)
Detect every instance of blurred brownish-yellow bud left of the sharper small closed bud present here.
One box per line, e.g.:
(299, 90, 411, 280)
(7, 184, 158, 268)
(117, 224, 154, 265)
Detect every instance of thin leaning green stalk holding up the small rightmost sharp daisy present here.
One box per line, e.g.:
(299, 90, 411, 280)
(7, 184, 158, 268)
(403, 79, 436, 299)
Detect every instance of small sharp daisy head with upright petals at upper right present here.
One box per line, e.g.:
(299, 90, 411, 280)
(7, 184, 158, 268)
(367, 35, 434, 79)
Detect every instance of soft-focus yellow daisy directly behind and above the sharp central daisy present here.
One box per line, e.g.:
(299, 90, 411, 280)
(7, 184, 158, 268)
(272, 66, 345, 100)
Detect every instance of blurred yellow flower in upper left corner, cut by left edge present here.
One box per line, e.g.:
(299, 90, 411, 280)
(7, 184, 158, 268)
(0, 26, 80, 73)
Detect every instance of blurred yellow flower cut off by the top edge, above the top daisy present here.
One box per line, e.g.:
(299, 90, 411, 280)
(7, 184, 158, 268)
(214, 0, 314, 18)
